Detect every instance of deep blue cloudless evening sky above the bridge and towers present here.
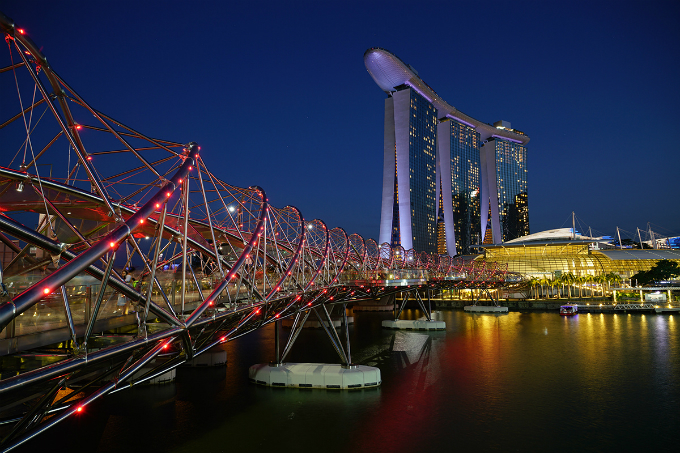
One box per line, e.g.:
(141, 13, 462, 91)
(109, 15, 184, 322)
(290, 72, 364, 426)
(0, 0, 680, 242)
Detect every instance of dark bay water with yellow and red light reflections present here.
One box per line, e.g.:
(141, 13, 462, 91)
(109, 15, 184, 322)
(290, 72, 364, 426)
(18, 309, 680, 453)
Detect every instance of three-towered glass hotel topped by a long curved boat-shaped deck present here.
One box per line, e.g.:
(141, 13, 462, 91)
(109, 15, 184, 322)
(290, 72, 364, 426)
(364, 48, 529, 256)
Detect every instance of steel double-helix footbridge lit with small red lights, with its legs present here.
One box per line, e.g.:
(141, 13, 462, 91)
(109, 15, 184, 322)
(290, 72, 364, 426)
(0, 13, 508, 451)
